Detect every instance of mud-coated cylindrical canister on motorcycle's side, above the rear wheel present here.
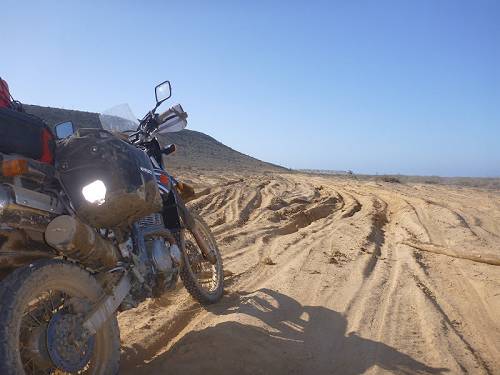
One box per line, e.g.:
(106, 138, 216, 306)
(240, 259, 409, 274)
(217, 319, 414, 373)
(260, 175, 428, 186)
(45, 215, 120, 269)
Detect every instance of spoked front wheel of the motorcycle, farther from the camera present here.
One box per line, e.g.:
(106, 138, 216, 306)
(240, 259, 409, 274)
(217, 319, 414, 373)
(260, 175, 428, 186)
(180, 213, 224, 305)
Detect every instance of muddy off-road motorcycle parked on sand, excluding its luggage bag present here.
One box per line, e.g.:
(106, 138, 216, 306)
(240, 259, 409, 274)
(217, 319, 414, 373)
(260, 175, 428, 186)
(0, 81, 224, 374)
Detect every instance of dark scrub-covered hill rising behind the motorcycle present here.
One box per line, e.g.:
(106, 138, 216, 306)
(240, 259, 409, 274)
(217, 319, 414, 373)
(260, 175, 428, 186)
(24, 105, 288, 172)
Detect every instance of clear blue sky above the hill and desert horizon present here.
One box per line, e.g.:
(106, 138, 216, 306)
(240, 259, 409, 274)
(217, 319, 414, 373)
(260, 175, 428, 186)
(0, 0, 500, 176)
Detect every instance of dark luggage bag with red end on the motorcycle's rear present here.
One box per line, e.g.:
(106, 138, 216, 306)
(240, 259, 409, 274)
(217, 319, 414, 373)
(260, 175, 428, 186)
(0, 108, 55, 163)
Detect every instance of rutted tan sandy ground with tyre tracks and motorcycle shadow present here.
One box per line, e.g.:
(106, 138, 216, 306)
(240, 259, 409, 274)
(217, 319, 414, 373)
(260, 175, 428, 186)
(119, 172, 500, 375)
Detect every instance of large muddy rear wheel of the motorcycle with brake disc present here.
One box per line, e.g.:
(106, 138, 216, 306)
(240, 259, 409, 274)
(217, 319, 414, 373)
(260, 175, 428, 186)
(0, 260, 120, 375)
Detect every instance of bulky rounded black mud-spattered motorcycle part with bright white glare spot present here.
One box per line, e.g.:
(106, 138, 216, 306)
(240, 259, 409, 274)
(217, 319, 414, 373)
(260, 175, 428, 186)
(56, 129, 162, 228)
